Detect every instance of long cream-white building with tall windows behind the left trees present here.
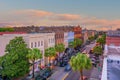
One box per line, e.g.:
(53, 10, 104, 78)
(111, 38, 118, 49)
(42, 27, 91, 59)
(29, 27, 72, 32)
(0, 33, 55, 65)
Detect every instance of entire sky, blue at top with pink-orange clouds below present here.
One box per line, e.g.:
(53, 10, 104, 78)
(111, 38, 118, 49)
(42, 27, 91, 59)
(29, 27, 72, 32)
(0, 0, 120, 30)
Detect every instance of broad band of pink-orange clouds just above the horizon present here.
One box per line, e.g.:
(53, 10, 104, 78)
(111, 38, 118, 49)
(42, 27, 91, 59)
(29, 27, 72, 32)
(0, 9, 120, 30)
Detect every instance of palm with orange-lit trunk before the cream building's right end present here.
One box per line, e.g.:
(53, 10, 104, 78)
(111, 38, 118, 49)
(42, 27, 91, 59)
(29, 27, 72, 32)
(45, 47, 56, 64)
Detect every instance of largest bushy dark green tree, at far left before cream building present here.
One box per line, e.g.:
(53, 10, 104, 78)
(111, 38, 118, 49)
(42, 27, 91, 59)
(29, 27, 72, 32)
(0, 37, 29, 79)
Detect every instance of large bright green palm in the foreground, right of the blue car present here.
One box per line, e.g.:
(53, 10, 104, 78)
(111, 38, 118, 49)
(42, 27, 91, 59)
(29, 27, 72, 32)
(70, 53, 92, 80)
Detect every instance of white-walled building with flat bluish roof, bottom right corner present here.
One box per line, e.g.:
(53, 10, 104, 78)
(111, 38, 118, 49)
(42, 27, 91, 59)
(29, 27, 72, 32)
(101, 45, 120, 80)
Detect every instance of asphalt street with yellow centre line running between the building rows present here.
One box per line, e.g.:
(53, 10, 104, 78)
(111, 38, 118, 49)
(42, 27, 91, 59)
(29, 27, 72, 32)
(48, 43, 96, 80)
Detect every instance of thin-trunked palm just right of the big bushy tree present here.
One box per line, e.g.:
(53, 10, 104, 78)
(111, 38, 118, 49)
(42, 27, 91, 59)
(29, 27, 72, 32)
(27, 48, 42, 78)
